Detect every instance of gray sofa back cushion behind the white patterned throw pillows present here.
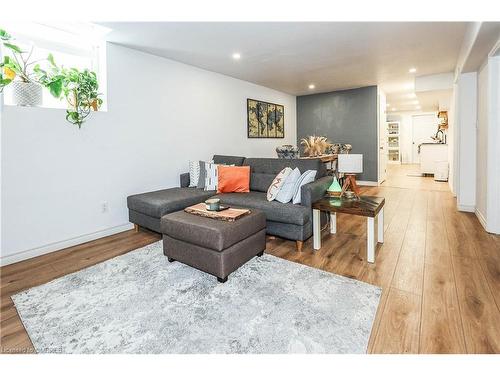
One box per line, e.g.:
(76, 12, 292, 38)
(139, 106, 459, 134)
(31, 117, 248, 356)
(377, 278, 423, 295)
(243, 158, 326, 192)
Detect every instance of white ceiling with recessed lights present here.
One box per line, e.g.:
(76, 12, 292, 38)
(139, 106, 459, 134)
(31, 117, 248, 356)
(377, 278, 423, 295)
(101, 22, 467, 110)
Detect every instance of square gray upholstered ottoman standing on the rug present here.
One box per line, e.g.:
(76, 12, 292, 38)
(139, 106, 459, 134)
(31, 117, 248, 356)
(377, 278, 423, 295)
(161, 210, 266, 282)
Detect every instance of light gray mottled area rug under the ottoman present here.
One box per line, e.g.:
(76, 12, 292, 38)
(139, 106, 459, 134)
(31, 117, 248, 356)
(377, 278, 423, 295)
(12, 242, 381, 353)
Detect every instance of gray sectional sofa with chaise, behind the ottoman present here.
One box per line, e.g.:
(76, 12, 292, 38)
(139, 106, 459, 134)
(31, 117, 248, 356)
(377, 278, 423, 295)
(127, 155, 333, 250)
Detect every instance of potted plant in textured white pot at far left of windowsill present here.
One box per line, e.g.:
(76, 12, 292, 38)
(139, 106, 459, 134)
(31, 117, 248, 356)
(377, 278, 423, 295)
(0, 30, 42, 106)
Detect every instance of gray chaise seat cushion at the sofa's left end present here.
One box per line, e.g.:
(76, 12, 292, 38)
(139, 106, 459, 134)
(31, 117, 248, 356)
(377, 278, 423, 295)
(127, 188, 215, 218)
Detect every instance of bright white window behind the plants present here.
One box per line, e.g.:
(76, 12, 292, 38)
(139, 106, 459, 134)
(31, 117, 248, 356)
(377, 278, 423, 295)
(1, 22, 108, 110)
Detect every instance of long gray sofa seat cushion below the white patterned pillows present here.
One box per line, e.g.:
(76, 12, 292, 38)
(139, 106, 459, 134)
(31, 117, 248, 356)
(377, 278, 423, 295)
(216, 191, 311, 225)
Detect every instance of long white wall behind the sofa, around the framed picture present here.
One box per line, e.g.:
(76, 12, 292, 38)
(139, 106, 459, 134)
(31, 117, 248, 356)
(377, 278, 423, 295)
(1, 45, 296, 264)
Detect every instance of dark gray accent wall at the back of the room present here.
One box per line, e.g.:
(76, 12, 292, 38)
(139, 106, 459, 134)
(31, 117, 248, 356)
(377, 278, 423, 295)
(297, 86, 378, 181)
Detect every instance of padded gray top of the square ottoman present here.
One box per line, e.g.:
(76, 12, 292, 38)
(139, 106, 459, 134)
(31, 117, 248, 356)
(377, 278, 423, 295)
(161, 210, 266, 251)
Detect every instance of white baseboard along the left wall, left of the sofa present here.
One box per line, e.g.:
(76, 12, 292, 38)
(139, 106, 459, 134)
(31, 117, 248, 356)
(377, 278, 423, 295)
(0, 223, 134, 266)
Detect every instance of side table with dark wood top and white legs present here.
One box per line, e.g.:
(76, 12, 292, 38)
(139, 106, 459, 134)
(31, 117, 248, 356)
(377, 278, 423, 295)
(312, 196, 385, 263)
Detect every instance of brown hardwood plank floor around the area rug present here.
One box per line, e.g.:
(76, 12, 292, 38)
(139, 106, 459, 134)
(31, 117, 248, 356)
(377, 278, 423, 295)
(0, 166, 500, 353)
